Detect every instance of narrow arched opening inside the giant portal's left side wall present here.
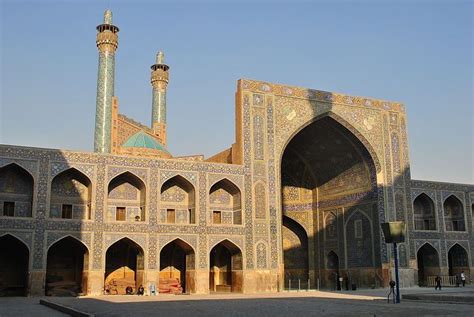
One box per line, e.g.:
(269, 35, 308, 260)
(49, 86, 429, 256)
(282, 216, 309, 288)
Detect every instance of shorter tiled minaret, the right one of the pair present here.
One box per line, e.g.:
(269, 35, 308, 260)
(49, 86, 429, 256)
(151, 51, 169, 146)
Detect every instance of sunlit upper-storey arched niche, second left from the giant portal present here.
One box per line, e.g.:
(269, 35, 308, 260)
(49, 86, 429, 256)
(160, 175, 196, 224)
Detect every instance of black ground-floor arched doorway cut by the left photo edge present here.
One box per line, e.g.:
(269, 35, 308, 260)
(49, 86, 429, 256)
(0, 234, 29, 297)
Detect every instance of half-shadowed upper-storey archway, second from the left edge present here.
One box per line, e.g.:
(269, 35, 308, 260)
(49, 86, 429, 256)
(50, 168, 92, 220)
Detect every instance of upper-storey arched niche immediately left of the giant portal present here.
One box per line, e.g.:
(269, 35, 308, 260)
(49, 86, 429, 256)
(209, 178, 242, 225)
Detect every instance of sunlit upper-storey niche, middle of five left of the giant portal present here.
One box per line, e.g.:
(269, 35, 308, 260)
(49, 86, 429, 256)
(107, 172, 146, 222)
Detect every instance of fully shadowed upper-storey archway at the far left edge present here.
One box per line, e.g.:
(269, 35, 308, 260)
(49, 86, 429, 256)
(0, 163, 33, 217)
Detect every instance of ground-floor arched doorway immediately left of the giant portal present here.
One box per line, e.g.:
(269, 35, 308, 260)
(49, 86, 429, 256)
(209, 240, 243, 293)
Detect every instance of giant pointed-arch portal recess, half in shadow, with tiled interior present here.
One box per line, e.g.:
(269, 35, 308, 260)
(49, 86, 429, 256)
(281, 114, 382, 288)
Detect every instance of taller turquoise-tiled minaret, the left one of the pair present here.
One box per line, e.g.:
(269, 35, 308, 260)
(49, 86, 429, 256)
(94, 9, 119, 153)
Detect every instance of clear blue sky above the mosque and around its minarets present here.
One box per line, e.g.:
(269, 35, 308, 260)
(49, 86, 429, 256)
(0, 0, 474, 183)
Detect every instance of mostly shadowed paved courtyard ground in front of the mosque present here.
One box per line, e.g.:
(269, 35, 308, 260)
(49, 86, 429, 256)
(0, 287, 474, 317)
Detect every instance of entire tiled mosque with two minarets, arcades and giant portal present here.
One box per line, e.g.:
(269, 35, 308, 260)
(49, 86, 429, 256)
(0, 10, 474, 296)
